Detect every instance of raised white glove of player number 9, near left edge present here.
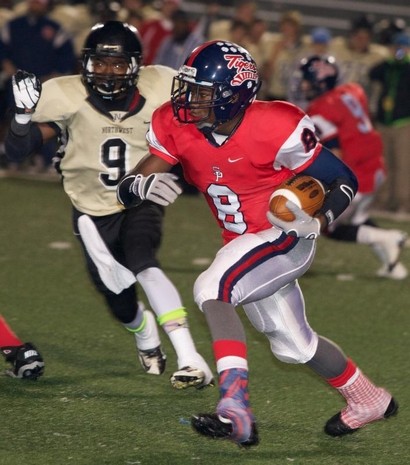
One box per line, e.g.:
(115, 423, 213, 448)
(12, 70, 41, 124)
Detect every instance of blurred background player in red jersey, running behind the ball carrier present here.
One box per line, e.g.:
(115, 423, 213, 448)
(299, 55, 408, 279)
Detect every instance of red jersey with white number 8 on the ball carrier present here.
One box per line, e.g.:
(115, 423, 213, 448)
(147, 101, 322, 242)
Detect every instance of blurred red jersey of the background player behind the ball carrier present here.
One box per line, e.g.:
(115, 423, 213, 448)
(306, 82, 384, 193)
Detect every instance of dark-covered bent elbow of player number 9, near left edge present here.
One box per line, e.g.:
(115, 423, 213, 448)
(4, 118, 43, 162)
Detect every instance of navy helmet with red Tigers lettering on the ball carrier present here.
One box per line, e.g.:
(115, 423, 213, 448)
(171, 40, 260, 130)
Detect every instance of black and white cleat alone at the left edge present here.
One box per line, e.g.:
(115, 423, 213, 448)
(0, 342, 44, 380)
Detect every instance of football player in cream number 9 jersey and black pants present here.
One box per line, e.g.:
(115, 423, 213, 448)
(6, 21, 212, 389)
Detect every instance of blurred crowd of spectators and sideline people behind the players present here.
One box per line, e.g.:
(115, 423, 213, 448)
(0, 0, 410, 213)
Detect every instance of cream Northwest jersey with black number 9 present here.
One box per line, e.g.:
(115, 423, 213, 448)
(33, 65, 176, 216)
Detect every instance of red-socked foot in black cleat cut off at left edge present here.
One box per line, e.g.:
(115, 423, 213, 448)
(0, 315, 44, 380)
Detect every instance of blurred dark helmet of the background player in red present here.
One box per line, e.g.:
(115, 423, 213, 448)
(300, 55, 339, 100)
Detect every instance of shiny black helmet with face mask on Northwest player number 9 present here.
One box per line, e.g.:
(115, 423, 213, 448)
(82, 21, 142, 99)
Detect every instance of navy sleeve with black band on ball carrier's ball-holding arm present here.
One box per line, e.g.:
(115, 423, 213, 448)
(303, 147, 358, 224)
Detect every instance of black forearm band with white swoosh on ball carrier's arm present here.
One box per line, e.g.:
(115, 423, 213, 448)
(320, 177, 358, 224)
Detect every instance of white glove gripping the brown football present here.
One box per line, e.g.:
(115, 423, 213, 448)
(266, 200, 321, 239)
